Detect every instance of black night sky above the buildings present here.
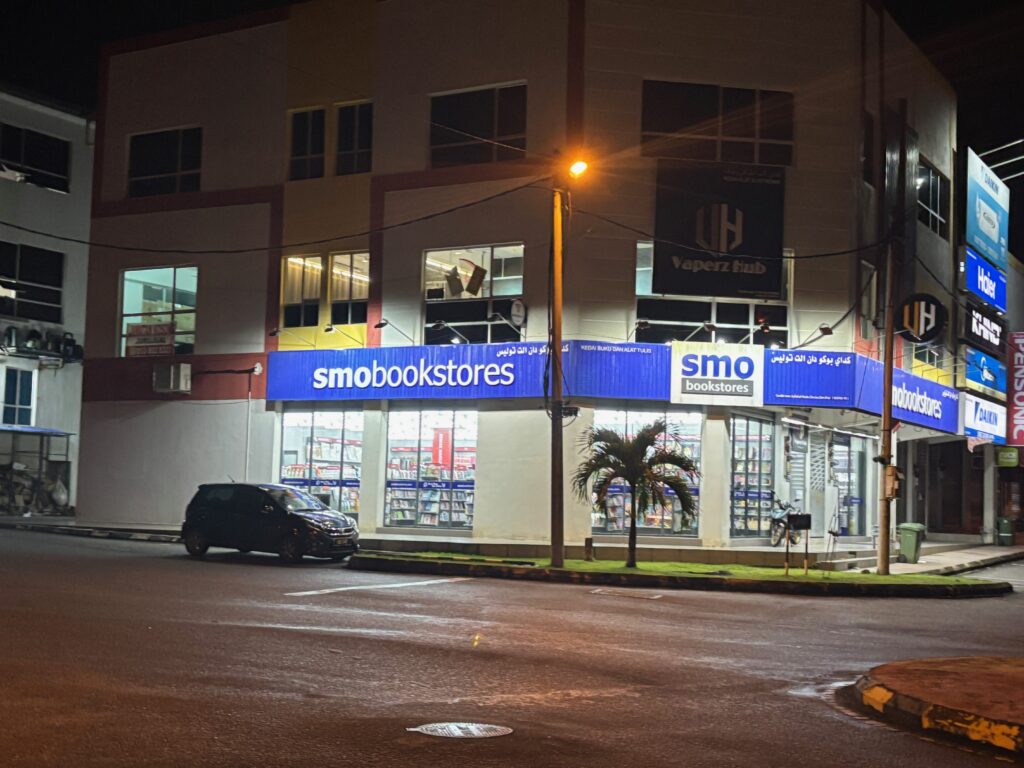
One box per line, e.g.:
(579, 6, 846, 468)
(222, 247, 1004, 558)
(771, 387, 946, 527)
(6, 0, 1024, 254)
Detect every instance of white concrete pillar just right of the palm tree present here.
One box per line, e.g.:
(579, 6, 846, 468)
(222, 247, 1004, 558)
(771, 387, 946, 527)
(698, 409, 732, 547)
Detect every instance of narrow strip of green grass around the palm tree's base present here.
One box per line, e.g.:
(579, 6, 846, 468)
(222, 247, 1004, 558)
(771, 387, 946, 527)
(368, 552, 984, 585)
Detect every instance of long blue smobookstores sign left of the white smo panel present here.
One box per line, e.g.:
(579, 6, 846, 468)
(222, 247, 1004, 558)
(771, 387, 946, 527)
(267, 341, 671, 400)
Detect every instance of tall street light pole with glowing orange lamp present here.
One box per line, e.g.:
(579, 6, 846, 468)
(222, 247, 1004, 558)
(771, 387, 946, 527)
(548, 160, 587, 568)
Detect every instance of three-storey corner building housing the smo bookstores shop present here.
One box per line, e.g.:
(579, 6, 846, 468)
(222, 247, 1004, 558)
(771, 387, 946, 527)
(80, 0, 991, 546)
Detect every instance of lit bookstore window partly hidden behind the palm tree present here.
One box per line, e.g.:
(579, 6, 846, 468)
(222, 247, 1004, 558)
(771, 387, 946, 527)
(591, 411, 703, 536)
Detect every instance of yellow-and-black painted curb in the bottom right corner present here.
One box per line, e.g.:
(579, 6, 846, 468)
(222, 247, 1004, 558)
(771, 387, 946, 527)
(846, 673, 1024, 755)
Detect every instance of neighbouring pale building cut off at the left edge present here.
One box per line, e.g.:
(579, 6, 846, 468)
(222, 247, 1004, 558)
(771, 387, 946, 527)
(0, 88, 93, 514)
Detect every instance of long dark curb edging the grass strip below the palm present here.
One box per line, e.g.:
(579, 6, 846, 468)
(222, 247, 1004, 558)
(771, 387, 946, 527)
(348, 553, 1014, 598)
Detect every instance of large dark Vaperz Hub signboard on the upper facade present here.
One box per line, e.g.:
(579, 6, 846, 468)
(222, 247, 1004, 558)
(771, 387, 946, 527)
(653, 161, 785, 299)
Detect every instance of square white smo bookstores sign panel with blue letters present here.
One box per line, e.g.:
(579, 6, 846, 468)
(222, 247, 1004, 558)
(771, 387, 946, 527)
(672, 341, 764, 406)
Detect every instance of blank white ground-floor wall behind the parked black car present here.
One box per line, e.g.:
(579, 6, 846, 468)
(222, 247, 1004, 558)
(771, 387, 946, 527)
(77, 399, 278, 528)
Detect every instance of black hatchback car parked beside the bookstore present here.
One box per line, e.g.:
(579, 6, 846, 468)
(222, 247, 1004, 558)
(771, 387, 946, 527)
(181, 482, 359, 562)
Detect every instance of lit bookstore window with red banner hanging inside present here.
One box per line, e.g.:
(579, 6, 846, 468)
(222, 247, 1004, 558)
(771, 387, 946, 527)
(384, 411, 477, 528)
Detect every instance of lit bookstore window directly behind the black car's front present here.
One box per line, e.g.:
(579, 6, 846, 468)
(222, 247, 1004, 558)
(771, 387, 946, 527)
(281, 411, 362, 518)
